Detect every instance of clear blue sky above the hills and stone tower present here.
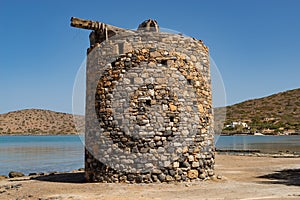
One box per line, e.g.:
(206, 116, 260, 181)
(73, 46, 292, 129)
(0, 0, 300, 113)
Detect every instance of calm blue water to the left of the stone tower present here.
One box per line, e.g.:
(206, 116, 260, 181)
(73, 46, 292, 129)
(0, 136, 84, 175)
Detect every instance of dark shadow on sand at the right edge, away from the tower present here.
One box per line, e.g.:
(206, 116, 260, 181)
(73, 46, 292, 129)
(257, 168, 300, 186)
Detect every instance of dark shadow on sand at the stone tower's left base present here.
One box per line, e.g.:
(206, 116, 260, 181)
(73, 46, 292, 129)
(31, 172, 86, 183)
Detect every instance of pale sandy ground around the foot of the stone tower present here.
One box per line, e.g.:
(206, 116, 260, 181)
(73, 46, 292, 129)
(0, 155, 300, 200)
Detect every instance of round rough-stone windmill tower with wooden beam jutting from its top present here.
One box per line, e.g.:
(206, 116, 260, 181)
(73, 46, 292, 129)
(71, 18, 214, 183)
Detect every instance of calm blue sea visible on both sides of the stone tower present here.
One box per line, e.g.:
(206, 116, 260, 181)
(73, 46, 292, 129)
(0, 135, 300, 175)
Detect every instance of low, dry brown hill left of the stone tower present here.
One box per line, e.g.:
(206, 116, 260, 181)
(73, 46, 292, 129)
(0, 109, 83, 134)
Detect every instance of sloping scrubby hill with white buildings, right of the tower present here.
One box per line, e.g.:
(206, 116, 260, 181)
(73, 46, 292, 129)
(215, 89, 300, 134)
